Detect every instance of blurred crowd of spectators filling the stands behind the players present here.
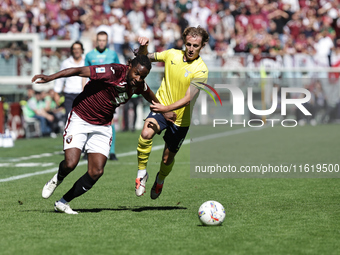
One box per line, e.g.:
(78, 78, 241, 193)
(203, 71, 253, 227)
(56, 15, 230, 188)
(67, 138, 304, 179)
(0, 0, 340, 66)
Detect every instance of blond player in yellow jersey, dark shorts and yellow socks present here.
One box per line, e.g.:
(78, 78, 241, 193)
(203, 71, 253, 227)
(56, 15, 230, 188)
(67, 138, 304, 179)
(135, 26, 209, 199)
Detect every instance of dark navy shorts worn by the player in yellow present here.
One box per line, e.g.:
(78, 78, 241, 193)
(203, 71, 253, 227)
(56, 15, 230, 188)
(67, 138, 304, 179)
(147, 112, 189, 153)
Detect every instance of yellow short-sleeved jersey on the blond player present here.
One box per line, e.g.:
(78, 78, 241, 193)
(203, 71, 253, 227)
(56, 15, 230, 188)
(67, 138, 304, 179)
(154, 49, 208, 127)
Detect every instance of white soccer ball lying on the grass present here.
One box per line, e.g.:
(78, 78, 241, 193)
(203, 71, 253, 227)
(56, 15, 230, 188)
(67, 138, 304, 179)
(198, 201, 225, 226)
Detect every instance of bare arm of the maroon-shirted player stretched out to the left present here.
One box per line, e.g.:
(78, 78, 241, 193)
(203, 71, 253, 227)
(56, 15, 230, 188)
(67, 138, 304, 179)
(32, 66, 91, 83)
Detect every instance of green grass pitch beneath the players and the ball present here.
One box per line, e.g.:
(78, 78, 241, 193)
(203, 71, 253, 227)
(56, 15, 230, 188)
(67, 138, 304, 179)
(0, 125, 340, 255)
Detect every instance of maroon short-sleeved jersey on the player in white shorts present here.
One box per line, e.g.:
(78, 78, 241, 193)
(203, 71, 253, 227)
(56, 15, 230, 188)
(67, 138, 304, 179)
(73, 64, 149, 125)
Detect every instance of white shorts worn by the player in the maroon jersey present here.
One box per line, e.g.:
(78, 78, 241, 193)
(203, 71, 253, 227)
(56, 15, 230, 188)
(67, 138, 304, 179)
(63, 111, 112, 157)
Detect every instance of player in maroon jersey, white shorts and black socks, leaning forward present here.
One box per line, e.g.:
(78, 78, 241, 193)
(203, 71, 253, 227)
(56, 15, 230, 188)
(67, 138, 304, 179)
(32, 55, 173, 214)
